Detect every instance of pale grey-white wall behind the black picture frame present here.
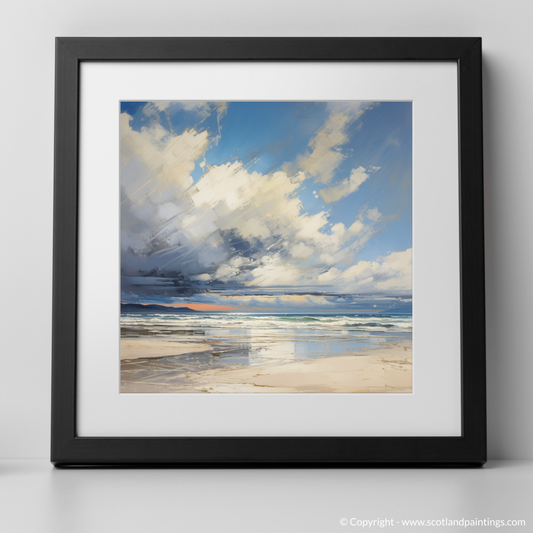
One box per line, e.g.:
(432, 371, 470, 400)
(0, 0, 533, 459)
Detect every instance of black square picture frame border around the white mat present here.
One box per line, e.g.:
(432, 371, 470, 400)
(51, 37, 487, 466)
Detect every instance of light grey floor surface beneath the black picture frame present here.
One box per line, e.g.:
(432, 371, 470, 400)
(0, 460, 533, 533)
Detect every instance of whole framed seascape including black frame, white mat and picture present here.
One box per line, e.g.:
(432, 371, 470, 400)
(51, 38, 486, 466)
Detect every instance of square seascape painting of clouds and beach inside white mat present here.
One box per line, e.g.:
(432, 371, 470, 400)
(119, 100, 413, 394)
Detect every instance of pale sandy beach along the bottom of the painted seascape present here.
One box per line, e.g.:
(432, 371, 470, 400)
(121, 339, 412, 393)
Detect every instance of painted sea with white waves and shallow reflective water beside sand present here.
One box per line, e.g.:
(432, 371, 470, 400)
(121, 313, 413, 364)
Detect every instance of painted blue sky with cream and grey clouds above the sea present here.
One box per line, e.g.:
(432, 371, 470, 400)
(120, 101, 412, 311)
